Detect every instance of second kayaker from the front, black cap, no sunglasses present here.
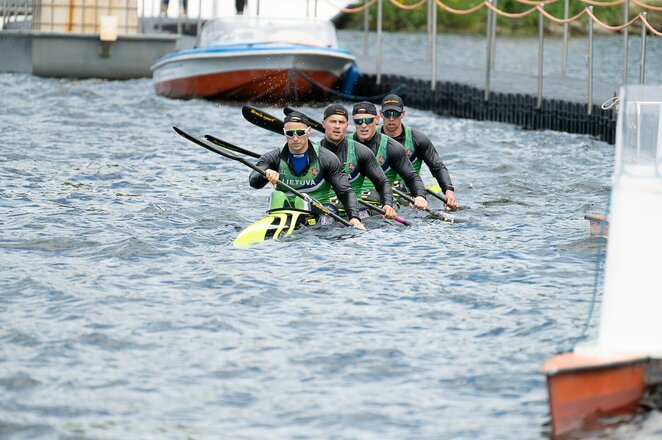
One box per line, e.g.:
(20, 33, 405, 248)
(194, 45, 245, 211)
(320, 104, 397, 219)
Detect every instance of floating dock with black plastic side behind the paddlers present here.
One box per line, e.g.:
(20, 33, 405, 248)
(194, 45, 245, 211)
(355, 59, 616, 144)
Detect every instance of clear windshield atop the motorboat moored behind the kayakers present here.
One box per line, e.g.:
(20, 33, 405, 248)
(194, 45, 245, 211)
(196, 16, 338, 47)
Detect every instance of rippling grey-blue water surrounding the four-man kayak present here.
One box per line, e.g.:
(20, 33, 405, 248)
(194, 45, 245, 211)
(0, 70, 662, 439)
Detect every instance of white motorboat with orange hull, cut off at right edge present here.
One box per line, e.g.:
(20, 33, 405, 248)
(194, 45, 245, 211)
(543, 85, 662, 437)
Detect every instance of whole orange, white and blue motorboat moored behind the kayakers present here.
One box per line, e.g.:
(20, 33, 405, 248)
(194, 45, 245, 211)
(151, 15, 358, 102)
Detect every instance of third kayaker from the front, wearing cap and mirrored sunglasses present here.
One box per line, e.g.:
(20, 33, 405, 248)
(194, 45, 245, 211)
(352, 101, 428, 209)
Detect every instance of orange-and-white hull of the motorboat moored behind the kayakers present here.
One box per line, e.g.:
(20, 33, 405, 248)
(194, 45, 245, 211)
(152, 49, 354, 101)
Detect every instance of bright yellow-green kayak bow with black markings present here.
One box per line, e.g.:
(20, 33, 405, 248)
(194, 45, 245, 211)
(233, 208, 319, 247)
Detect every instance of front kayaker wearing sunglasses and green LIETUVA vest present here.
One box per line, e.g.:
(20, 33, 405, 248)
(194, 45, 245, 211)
(249, 112, 365, 229)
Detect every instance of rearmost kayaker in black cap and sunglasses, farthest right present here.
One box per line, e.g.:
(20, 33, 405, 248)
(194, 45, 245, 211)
(381, 94, 457, 210)
